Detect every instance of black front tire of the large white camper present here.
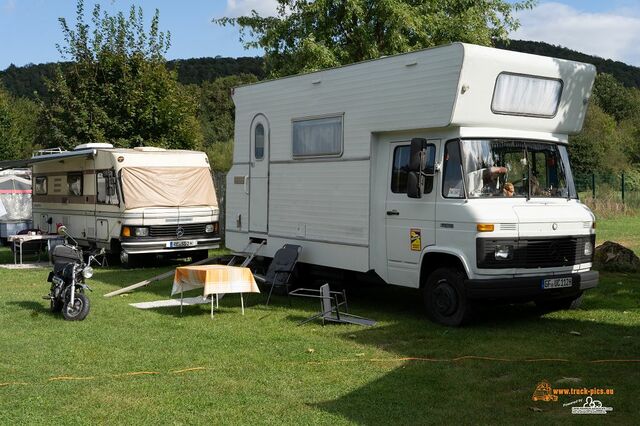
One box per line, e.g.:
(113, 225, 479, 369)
(423, 268, 471, 327)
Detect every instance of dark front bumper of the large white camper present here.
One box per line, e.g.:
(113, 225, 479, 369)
(464, 271, 600, 300)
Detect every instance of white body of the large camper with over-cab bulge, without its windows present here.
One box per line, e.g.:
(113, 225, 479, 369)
(226, 43, 595, 287)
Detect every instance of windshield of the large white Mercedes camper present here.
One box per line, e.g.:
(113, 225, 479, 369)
(461, 139, 576, 198)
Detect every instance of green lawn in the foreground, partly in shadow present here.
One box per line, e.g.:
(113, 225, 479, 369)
(0, 245, 640, 424)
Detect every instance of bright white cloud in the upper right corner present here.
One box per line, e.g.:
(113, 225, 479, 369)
(510, 2, 640, 66)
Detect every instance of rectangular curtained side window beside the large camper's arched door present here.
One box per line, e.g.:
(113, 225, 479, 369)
(293, 116, 342, 158)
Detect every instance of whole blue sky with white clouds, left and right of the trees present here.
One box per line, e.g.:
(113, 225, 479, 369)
(0, 0, 640, 70)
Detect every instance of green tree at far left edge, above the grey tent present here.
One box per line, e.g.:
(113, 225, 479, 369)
(0, 86, 38, 160)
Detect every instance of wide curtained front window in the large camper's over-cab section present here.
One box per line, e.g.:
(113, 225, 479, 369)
(491, 73, 562, 118)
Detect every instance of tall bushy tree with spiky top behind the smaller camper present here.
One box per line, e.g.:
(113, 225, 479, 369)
(40, 0, 202, 148)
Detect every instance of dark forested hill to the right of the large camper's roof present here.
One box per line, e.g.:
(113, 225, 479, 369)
(496, 40, 640, 88)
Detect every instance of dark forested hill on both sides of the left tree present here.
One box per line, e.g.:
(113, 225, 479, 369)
(0, 57, 264, 99)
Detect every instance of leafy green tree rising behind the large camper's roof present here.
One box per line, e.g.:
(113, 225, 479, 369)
(214, 0, 536, 77)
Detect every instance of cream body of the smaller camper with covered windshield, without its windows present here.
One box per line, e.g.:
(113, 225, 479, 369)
(32, 148, 220, 254)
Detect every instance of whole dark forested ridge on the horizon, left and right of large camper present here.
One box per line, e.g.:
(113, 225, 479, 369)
(0, 40, 640, 99)
